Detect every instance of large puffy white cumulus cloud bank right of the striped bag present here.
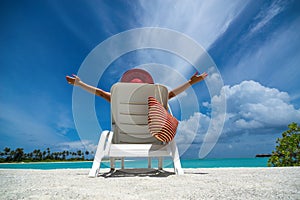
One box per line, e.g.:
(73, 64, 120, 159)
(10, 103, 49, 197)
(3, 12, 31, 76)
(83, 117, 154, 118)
(176, 81, 300, 156)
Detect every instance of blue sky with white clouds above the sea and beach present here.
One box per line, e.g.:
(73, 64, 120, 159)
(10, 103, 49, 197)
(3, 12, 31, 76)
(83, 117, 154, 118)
(0, 0, 300, 158)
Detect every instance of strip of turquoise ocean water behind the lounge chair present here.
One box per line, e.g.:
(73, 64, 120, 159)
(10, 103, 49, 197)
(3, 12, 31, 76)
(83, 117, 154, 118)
(0, 158, 268, 170)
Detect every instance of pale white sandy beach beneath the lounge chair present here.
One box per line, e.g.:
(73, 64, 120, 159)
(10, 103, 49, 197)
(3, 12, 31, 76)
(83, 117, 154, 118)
(0, 167, 300, 200)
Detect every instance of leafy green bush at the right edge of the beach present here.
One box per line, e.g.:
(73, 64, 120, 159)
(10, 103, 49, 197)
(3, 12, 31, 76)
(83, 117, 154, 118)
(268, 122, 300, 167)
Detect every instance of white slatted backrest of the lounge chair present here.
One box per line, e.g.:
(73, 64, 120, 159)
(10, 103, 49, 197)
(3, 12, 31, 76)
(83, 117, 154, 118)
(111, 83, 168, 144)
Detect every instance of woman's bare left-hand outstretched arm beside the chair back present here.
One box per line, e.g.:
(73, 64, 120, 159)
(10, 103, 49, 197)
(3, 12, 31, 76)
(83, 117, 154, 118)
(66, 74, 110, 102)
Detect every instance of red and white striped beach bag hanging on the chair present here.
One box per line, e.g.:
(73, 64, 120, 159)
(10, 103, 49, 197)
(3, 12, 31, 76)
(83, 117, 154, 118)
(148, 97, 178, 142)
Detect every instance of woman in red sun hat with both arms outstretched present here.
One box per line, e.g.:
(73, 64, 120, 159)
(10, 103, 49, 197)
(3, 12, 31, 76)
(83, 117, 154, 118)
(66, 69, 207, 102)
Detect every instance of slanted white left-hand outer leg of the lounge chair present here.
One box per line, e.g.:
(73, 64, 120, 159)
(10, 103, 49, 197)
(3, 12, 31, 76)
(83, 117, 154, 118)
(89, 131, 110, 178)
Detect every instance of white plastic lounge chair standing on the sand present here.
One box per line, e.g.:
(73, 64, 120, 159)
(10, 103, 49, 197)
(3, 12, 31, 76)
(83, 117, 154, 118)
(89, 83, 183, 177)
